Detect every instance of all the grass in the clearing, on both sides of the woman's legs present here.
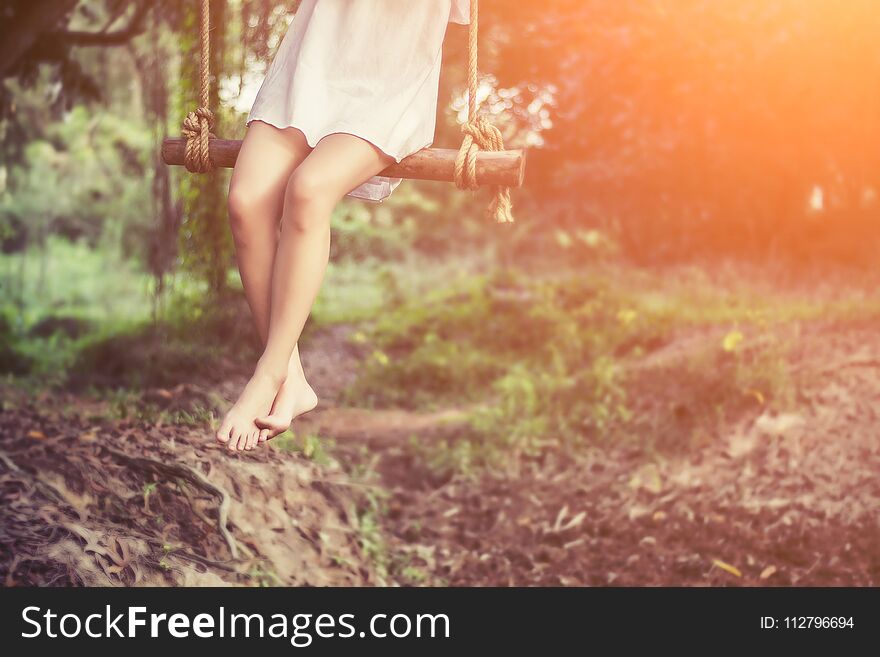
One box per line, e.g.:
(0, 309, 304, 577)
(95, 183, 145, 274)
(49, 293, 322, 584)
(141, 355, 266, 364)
(6, 233, 880, 470)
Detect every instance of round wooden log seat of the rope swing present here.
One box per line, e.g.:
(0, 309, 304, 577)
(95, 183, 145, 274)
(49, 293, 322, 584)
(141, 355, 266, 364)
(162, 138, 526, 187)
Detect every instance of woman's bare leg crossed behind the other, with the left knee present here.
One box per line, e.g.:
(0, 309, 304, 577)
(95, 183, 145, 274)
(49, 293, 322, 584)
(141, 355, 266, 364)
(217, 121, 317, 446)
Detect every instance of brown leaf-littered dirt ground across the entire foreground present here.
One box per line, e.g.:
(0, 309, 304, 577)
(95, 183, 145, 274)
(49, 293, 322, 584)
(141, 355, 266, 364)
(0, 323, 880, 586)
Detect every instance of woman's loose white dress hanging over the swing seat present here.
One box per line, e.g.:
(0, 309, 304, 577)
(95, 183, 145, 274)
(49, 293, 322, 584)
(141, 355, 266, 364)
(247, 0, 470, 201)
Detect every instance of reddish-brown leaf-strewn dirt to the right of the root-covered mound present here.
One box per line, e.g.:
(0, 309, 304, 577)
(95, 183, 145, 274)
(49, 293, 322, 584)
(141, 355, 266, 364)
(303, 324, 880, 586)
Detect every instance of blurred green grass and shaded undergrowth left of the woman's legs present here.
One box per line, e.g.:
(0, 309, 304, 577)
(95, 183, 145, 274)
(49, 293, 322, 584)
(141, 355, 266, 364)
(0, 237, 258, 386)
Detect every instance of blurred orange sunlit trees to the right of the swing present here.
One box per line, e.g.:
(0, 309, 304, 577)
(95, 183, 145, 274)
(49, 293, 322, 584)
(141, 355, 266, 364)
(484, 0, 880, 262)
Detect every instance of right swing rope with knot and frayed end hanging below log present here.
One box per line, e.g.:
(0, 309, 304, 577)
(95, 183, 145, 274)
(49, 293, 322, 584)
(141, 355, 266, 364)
(455, 0, 513, 223)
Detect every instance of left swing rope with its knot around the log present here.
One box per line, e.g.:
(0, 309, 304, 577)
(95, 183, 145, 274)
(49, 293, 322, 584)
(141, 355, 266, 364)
(181, 0, 216, 173)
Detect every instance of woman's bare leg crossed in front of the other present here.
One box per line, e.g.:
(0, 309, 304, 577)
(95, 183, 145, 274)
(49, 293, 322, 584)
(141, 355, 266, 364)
(223, 133, 392, 450)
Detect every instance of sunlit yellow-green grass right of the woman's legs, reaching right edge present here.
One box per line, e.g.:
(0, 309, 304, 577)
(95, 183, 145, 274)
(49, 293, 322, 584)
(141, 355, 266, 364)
(347, 264, 880, 473)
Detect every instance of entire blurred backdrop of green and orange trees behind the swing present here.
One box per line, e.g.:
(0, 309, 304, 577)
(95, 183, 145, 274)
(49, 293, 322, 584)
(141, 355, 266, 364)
(0, 0, 880, 384)
